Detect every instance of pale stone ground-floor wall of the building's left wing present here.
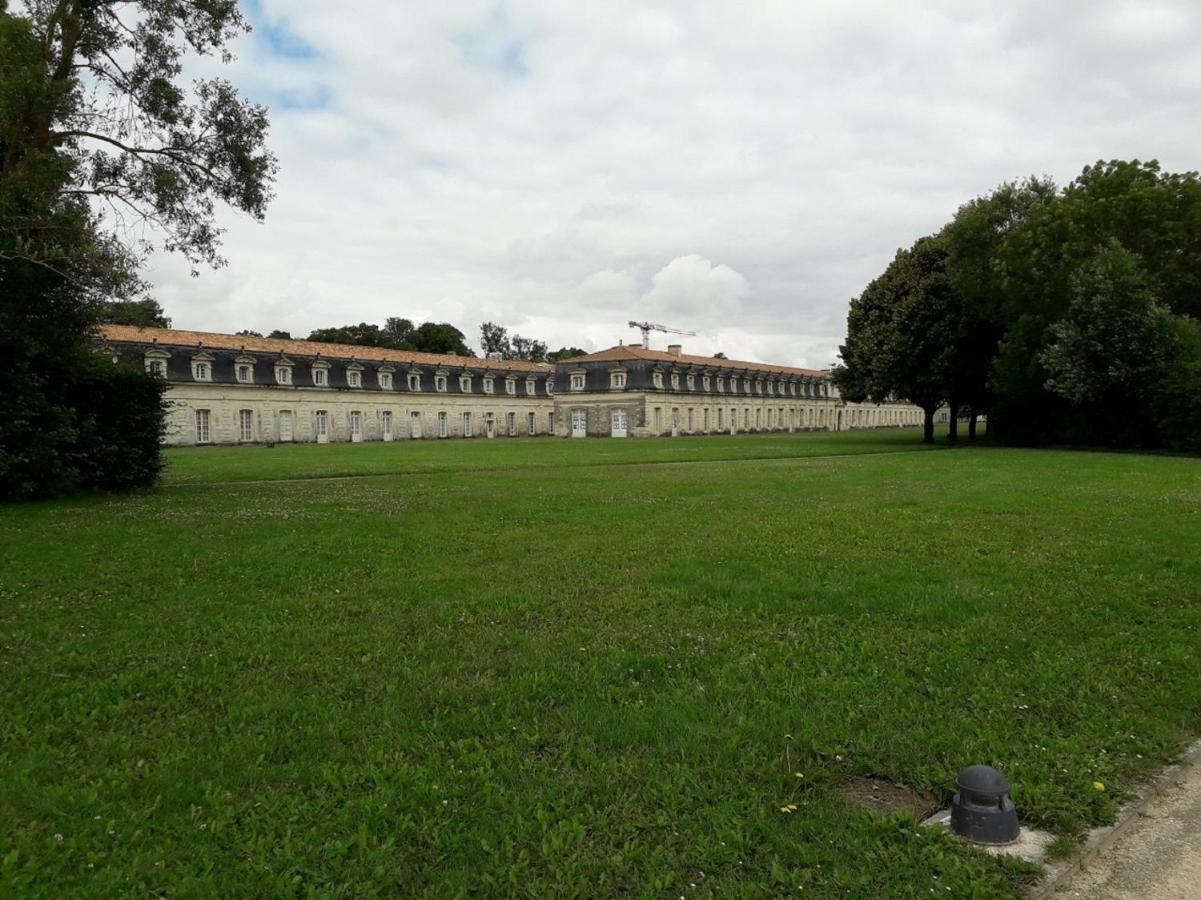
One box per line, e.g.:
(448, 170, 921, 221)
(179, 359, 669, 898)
(166, 383, 554, 446)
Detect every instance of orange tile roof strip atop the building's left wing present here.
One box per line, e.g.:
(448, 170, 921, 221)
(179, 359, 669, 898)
(100, 324, 550, 372)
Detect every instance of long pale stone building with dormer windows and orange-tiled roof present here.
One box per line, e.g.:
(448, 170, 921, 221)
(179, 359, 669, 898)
(101, 326, 922, 445)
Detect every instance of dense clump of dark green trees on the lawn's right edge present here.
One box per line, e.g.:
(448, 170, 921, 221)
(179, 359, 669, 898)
(835, 160, 1201, 451)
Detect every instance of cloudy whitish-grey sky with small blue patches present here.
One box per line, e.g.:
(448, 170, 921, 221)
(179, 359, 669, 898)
(150, 0, 1201, 366)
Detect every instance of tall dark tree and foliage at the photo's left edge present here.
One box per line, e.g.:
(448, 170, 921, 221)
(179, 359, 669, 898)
(0, 0, 275, 496)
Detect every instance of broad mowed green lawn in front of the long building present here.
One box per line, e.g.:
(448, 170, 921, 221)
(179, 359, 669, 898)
(0, 431, 1201, 898)
